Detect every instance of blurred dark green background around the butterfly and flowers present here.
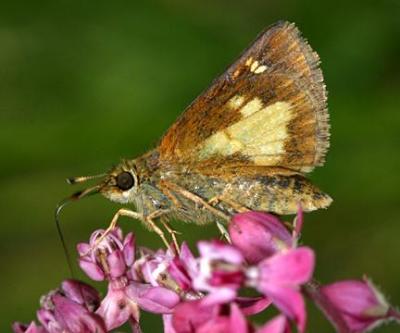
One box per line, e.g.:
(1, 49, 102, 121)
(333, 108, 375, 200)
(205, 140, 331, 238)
(0, 0, 400, 333)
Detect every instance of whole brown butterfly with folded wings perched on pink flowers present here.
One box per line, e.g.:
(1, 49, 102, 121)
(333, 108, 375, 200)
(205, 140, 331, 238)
(62, 22, 332, 246)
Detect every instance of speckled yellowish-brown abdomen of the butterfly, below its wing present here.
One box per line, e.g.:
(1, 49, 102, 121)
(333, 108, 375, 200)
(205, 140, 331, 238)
(162, 169, 332, 220)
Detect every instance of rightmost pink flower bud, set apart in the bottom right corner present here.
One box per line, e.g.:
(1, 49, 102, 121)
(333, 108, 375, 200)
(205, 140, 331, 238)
(319, 279, 400, 333)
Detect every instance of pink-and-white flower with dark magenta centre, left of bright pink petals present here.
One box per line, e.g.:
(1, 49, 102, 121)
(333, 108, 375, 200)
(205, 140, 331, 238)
(168, 241, 270, 308)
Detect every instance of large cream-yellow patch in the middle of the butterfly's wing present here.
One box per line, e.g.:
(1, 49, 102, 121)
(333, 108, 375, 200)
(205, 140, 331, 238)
(198, 98, 293, 165)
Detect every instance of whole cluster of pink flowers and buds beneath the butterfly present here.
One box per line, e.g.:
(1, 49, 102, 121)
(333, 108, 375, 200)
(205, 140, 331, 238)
(13, 211, 400, 333)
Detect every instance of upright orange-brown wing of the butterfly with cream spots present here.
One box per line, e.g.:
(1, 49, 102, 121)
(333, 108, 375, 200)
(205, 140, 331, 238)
(158, 22, 329, 172)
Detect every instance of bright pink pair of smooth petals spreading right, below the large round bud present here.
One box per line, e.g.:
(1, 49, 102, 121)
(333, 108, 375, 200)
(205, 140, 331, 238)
(247, 247, 315, 332)
